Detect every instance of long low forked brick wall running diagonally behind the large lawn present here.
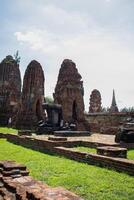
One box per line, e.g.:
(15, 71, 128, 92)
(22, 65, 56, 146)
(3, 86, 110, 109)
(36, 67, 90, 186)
(0, 134, 134, 175)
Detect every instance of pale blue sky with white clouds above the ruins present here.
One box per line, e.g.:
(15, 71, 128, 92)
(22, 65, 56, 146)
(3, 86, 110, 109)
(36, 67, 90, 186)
(0, 0, 134, 111)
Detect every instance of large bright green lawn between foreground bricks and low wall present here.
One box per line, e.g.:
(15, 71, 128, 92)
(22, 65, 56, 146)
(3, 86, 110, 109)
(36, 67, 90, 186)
(0, 139, 134, 200)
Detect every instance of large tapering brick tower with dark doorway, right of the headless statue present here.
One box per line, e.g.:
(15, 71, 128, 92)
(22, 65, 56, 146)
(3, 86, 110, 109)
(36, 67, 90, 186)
(53, 59, 84, 129)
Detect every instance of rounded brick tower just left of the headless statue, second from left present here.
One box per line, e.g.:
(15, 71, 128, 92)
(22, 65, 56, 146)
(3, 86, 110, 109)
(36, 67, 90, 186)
(16, 60, 44, 128)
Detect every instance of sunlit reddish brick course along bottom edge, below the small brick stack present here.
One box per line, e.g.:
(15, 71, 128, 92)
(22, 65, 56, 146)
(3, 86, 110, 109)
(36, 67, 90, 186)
(3, 176, 81, 200)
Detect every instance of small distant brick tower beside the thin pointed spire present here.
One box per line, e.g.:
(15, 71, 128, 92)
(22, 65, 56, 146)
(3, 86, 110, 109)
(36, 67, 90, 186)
(89, 89, 102, 113)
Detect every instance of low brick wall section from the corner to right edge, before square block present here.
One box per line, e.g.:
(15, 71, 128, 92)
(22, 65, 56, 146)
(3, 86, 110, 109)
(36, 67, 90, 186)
(54, 147, 134, 175)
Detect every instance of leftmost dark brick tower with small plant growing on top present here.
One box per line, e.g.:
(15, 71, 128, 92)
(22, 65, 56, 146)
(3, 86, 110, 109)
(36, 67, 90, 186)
(0, 55, 21, 125)
